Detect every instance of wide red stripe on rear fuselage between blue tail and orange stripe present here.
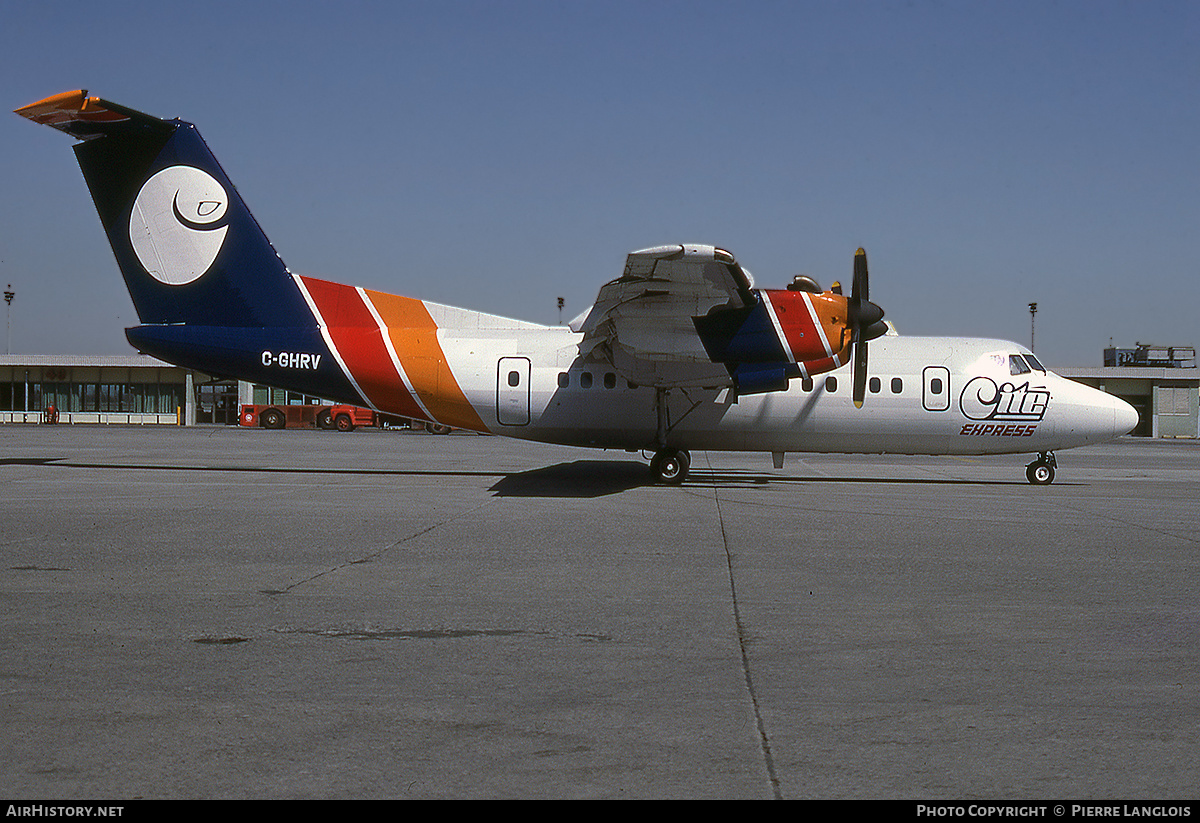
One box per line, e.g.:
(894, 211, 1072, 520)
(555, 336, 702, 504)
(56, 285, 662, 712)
(301, 277, 425, 420)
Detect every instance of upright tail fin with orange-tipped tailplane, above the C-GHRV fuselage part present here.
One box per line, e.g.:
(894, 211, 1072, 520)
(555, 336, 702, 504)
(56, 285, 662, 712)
(17, 90, 316, 328)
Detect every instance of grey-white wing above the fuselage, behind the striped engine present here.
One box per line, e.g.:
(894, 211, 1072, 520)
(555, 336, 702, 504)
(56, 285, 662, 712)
(572, 245, 755, 386)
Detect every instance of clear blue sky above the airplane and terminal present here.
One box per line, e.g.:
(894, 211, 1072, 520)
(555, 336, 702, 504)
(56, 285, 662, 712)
(0, 0, 1200, 366)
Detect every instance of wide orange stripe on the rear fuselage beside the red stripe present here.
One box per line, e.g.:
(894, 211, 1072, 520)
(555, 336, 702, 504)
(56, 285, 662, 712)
(364, 289, 487, 432)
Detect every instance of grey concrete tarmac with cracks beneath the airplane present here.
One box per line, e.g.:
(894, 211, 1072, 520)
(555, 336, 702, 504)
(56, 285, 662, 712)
(0, 426, 1200, 799)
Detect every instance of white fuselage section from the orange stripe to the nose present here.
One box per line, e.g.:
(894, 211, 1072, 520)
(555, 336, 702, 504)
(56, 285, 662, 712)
(439, 328, 1138, 455)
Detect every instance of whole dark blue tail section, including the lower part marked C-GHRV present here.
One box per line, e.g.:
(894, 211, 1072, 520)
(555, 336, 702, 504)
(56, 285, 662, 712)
(17, 91, 361, 403)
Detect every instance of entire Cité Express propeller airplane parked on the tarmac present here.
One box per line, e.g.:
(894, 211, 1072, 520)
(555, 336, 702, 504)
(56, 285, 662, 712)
(16, 90, 1138, 485)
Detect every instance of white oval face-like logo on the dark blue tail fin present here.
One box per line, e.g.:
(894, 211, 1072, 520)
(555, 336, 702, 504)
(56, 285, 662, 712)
(130, 166, 229, 286)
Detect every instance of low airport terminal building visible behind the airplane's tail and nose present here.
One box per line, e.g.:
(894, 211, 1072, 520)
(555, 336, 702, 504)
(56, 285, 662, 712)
(0, 346, 1200, 438)
